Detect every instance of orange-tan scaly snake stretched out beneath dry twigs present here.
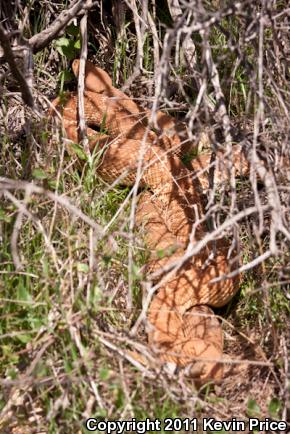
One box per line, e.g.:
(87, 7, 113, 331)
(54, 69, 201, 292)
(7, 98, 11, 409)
(53, 60, 248, 382)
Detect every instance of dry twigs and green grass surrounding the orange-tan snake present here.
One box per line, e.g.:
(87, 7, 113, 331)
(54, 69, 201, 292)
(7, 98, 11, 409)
(0, 0, 290, 434)
